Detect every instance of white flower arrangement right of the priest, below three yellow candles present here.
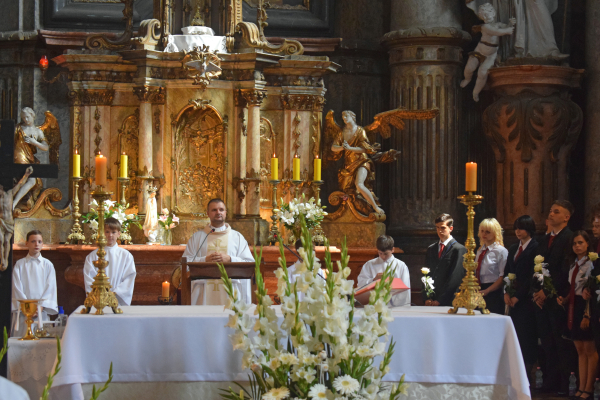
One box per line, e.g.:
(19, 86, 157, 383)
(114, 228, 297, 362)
(276, 194, 327, 243)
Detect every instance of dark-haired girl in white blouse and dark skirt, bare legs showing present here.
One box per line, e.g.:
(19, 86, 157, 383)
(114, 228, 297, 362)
(557, 231, 598, 399)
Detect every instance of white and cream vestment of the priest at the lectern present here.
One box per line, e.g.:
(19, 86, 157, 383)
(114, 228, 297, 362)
(183, 224, 254, 305)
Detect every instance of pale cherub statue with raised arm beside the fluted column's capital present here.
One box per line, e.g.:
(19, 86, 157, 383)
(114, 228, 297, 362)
(460, 3, 516, 101)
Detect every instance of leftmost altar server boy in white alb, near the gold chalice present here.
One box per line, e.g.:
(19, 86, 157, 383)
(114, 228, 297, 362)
(12, 230, 58, 336)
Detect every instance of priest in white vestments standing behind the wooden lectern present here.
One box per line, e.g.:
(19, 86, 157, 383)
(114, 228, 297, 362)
(183, 199, 254, 305)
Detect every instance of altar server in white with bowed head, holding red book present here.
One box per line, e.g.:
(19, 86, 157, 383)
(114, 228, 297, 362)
(358, 235, 410, 307)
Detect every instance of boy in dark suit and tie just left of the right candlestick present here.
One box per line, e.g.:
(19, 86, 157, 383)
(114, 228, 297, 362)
(425, 214, 467, 306)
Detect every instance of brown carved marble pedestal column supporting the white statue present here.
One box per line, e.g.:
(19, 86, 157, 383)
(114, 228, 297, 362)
(483, 65, 584, 230)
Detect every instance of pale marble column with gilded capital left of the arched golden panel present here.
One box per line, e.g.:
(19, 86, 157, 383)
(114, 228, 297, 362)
(133, 85, 165, 217)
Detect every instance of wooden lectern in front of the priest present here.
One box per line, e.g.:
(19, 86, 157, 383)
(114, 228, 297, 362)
(181, 257, 264, 306)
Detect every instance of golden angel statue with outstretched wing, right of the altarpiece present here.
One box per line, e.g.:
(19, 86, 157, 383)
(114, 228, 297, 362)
(325, 108, 439, 222)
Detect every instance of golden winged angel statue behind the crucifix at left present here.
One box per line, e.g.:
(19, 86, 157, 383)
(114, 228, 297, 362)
(13, 107, 62, 211)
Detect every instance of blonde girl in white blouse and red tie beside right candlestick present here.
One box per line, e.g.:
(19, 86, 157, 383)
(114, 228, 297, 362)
(475, 218, 508, 314)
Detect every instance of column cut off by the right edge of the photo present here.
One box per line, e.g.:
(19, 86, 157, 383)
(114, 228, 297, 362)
(584, 0, 600, 222)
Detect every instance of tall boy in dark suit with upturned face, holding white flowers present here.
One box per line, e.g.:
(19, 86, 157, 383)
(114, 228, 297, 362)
(533, 200, 577, 393)
